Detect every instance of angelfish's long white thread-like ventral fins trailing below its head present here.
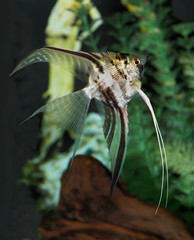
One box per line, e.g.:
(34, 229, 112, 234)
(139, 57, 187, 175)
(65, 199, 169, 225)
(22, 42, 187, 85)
(138, 89, 168, 214)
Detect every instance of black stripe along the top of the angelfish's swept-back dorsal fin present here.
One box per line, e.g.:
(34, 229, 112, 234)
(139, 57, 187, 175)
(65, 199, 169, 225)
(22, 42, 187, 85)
(45, 47, 104, 73)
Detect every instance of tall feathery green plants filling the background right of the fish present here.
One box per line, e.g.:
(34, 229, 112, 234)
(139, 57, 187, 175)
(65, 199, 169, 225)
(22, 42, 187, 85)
(106, 0, 194, 232)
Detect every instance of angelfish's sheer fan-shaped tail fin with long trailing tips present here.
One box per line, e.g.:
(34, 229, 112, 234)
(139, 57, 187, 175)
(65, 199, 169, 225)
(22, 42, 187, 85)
(21, 90, 90, 157)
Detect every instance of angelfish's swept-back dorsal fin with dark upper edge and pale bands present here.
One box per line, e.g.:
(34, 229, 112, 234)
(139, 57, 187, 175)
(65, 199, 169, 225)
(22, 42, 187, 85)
(10, 47, 94, 80)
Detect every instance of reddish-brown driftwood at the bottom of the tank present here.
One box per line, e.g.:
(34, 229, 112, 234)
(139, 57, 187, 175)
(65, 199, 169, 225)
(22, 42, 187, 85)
(40, 156, 194, 240)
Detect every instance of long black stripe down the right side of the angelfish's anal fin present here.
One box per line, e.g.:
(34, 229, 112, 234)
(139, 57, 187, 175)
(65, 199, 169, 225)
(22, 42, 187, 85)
(109, 108, 126, 198)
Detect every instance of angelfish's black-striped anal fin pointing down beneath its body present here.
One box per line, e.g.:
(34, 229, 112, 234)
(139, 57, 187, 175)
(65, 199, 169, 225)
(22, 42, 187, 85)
(97, 101, 128, 197)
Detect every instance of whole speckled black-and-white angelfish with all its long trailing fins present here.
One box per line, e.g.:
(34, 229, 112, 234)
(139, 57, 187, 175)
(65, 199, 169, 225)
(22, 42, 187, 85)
(11, 47, 168, 212)
